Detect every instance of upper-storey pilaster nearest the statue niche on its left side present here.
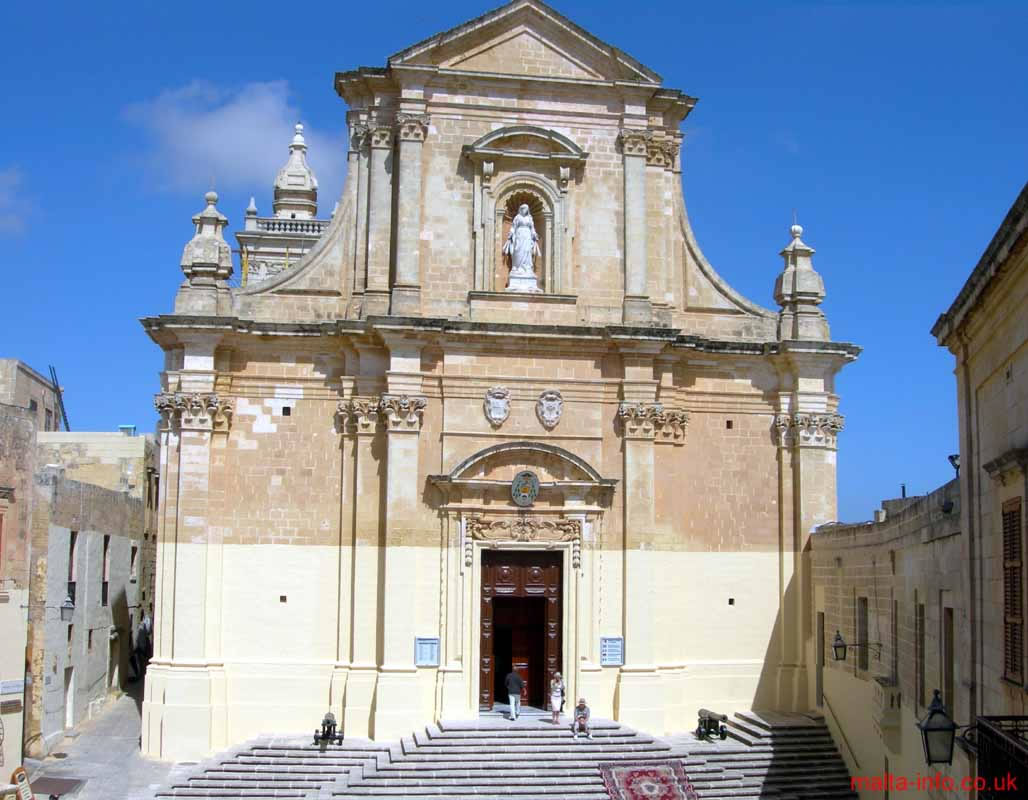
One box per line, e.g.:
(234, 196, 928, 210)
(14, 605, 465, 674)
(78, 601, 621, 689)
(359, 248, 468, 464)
(390, 114, 429, 317)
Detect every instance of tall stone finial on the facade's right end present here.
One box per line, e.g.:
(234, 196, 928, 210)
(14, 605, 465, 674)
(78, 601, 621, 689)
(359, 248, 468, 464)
(774, 223, 830, 341)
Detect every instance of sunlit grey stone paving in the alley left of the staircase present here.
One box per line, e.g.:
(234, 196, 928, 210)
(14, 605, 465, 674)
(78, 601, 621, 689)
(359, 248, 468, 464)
(26, 687, 180, 800)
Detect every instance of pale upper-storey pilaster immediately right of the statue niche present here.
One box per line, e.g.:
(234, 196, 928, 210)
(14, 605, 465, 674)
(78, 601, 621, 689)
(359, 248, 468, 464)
(621, 129, 653, 325)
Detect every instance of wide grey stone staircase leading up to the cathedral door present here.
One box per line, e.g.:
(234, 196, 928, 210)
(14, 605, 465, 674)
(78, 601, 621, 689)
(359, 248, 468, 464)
(155, 712, 856, 800)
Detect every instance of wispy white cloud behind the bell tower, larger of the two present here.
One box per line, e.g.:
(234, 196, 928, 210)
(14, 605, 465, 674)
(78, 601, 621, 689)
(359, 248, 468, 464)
(124, 80, 346, 202)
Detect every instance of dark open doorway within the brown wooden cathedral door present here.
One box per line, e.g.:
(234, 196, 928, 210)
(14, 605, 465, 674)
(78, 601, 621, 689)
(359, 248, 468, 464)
(492, 597, 546, 708)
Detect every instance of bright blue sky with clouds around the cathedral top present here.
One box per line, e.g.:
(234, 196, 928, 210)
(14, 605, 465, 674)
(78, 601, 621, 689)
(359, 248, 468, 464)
(0, 0, 1028, 520)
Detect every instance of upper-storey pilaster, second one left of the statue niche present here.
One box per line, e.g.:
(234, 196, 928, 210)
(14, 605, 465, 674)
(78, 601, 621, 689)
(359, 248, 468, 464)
(363, 125, 393, 317)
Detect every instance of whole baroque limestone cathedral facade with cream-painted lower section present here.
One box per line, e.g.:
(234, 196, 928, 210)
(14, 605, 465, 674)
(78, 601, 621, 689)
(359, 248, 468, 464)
(143, 0, 859, 759)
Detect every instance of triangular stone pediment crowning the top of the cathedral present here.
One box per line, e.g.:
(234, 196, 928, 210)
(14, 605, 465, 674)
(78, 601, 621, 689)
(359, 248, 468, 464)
(390, 0, 661, 84)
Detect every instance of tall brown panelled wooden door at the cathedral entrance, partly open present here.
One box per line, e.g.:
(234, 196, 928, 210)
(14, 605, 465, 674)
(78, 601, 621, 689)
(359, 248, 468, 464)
(479, 550, 563, 710)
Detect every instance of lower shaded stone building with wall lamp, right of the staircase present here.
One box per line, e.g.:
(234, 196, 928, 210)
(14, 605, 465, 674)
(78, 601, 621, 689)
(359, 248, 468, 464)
(810, 479, 974, 798)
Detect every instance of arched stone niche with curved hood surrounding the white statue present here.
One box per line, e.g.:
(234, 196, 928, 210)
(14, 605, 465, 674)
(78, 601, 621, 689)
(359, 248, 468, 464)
(464, 125, 588, 294)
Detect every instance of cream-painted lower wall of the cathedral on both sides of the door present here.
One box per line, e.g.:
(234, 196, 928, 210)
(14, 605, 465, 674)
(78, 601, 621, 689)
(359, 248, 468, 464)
(143, 544, 779, 760)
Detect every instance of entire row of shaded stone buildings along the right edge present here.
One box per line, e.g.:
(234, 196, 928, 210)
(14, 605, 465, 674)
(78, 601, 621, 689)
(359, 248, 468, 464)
(808, 180, 1028, 798)
